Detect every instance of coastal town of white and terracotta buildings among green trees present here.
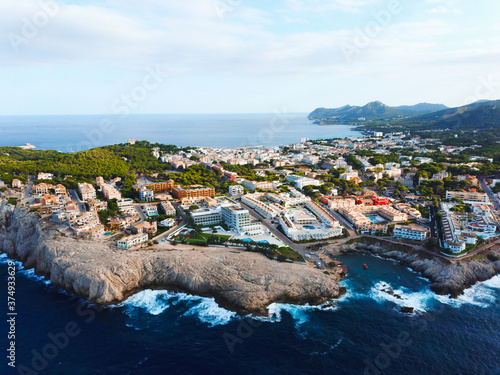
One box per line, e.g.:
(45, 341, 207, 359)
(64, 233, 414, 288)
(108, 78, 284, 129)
(0, 132, 500, 269)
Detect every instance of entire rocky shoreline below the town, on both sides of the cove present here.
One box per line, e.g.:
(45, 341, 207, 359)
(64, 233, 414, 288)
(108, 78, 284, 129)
(0, 201, 500, 316)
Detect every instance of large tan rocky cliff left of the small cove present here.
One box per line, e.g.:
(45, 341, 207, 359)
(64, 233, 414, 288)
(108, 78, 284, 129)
(0, 201, 340, 315)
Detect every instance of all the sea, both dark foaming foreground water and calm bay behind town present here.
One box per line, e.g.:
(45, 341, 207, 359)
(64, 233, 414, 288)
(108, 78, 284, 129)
(0, 114, 500, 375)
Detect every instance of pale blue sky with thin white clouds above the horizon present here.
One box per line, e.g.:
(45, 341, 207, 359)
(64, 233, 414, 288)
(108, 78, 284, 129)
(0, 0, 500, 115)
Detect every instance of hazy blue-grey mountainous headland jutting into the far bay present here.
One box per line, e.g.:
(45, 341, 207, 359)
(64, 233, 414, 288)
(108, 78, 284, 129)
(309, 101, 448, 122)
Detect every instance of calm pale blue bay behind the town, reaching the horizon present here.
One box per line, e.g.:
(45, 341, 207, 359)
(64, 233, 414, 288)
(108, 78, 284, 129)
(0, 111, 362, 152)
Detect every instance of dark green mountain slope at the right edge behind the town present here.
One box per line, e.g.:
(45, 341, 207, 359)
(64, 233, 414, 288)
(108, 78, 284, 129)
(409, 100, 500, 129)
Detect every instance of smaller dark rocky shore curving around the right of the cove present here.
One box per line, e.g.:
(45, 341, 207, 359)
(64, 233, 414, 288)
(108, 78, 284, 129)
(330, 241, 500, 297)
